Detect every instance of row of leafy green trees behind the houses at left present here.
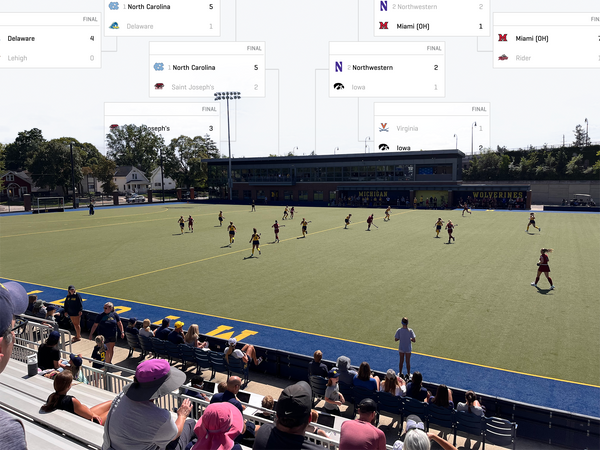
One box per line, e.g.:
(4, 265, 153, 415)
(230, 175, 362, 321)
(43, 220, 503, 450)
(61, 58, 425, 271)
(0, 125, 220, 194)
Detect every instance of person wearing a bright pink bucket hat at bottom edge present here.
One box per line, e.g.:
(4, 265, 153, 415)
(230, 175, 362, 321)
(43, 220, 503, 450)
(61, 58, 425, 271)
(192, 402, 245, 450)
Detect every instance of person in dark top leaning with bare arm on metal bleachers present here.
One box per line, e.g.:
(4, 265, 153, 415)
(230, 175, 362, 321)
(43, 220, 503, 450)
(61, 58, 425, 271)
(41, 370, 112, 425)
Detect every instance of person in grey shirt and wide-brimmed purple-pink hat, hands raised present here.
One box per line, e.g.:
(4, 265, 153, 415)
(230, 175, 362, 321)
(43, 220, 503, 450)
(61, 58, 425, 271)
(102, 359, 195, 450)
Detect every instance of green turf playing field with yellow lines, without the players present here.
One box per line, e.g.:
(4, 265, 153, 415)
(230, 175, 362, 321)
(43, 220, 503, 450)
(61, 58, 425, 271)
(0, 204, 600, 385)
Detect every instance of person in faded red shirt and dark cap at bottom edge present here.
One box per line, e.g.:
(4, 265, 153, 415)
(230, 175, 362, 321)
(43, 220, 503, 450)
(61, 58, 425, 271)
(339, 398, 385, 450)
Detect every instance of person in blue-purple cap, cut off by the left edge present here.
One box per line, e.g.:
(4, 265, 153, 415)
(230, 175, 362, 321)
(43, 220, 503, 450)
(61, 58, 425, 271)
(0, 281, 28, 450)
